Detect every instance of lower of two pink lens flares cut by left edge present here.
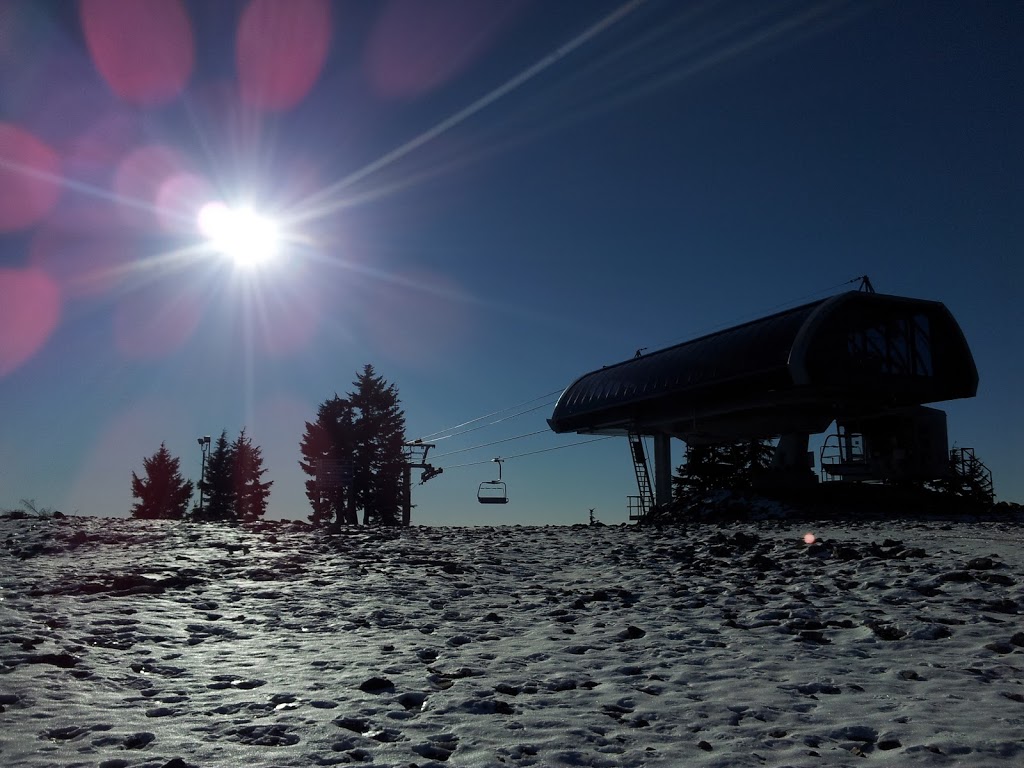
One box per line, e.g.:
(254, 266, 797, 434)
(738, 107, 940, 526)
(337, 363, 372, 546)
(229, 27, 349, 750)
(0, 268, 60, 376)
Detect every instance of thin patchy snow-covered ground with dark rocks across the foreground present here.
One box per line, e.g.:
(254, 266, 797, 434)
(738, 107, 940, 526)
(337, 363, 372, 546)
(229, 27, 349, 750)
(0, 517, 1024, 768)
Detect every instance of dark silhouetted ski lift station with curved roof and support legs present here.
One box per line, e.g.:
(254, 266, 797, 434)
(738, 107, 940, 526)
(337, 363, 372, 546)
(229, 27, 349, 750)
(548, 288, 978, 517)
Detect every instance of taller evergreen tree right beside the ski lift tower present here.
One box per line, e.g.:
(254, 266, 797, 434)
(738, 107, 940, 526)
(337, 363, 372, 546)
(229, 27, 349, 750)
(348, 365, 406, 525)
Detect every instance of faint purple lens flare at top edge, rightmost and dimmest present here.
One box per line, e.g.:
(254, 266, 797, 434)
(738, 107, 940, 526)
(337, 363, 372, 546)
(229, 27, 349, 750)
(365, 0, 522, 99)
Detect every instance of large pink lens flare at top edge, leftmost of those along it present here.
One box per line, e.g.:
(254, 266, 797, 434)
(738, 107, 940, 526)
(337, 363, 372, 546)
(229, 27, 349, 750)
(79, 0, 196, 105)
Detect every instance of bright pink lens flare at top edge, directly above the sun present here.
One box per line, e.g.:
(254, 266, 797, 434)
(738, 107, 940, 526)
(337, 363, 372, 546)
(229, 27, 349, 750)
(236, 0, 331, 111)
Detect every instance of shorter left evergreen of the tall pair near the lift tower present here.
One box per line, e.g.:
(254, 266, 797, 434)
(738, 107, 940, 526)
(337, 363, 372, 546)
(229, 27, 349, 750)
(299, 394, 357, 525)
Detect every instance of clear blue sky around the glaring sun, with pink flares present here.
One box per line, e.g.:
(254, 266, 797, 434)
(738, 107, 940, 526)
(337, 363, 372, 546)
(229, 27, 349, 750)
(0, 0, 1024, 524)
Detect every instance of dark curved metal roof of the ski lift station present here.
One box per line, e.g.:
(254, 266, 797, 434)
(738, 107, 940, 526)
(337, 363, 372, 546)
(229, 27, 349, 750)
(548, 291, 978, 439)
